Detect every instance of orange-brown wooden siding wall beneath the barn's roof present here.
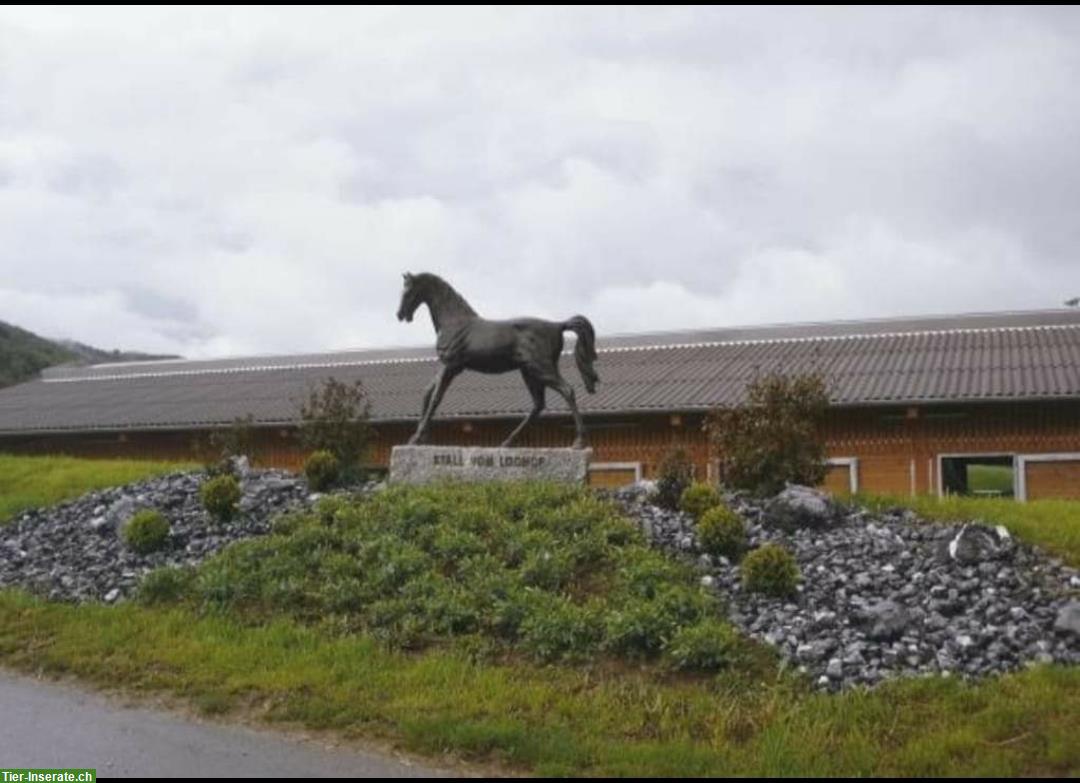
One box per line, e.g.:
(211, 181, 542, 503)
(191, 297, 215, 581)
(0, 403, 1080, 498)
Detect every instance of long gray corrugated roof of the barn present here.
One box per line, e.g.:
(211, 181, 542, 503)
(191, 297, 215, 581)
(0, 310, 1080, 433)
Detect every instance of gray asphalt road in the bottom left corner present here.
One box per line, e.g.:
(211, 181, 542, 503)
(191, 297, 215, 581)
(0, 672, 447, 778)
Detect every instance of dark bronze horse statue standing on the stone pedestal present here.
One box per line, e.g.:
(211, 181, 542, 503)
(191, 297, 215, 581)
(397, 272, 599, 448)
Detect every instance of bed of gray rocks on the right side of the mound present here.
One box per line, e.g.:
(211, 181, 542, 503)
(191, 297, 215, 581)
(616, 486, 1080, 690)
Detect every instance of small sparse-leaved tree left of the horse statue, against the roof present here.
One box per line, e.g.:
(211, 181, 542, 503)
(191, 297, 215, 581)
(299, 378, 373, 478)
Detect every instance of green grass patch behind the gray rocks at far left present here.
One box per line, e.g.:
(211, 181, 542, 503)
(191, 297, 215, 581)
(0, 454, 193, 524)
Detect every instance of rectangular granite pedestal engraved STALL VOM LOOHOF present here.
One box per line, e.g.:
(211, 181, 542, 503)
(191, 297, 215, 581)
(390, 446, 592, 484)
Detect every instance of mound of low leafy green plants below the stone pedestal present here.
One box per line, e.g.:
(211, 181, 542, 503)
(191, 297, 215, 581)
(152, 484, 737, 669)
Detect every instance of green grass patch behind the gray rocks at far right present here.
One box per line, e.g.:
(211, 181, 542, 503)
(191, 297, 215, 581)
(854, 496, 1080, 567)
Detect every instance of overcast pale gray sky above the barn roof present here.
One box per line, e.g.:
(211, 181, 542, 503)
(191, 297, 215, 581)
(0, 8, 1080, 356)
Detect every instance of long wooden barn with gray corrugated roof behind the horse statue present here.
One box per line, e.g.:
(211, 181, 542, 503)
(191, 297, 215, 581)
(0, 310, 1080, 500)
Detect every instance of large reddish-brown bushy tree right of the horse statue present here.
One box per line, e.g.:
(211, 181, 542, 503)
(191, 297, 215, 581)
(705, 373, 828, 496)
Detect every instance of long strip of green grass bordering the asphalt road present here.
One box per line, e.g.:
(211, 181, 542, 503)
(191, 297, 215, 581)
(0, 591, 1080, 777)
